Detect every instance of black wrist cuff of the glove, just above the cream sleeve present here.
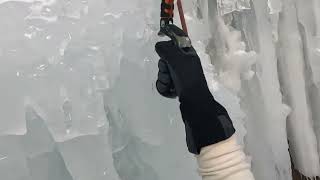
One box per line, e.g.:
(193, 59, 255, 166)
(180, 98, 235, 154)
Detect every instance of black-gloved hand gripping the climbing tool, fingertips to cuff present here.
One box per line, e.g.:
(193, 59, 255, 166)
(155, 25, 235, 154)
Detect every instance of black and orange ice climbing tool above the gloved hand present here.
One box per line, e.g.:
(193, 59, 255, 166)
(158, 0, 191, 48)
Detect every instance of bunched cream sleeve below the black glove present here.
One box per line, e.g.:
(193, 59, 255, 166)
(196, 135, 254, 180)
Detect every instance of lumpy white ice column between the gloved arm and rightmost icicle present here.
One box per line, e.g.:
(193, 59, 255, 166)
(201, 1, 291, 179)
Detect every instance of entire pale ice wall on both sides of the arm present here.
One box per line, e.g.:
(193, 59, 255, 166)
(0, 0, 320, 180)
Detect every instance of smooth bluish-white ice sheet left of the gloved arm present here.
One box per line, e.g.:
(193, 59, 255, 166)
(0, 0, 199, 180)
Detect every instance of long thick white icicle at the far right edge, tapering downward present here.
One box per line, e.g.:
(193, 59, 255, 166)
(279, 0, 320, 177)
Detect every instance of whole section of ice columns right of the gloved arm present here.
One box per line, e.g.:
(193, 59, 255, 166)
(201, 0, 320, 179)
